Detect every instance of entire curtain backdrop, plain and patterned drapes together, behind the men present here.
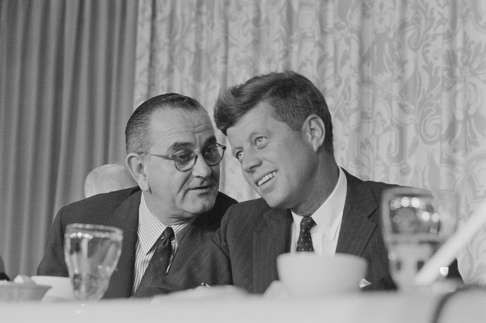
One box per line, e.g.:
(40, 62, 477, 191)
(0, 0, 486, 281)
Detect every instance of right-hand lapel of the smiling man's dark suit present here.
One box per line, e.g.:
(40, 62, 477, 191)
(336, 172, 378, 256)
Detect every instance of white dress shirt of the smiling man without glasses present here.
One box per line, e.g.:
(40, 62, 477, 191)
(290, 168, 347, 255)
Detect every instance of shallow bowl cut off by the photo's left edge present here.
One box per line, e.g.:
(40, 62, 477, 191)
(0, 281, 51, 302)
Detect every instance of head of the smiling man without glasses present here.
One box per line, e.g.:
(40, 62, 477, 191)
(214, 72, 337, 212)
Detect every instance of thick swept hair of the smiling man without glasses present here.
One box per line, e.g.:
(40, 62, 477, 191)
(214, 71, 333, 154)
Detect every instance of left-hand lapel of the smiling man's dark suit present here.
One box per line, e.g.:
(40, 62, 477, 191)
(252, 209, 292, 292)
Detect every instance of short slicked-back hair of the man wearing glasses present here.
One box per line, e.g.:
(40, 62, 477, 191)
(125, 93, 204, 153)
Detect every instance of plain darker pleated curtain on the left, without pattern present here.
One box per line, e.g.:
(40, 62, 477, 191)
(0, 0, 138, 276)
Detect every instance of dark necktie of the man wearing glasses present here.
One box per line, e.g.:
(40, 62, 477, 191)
(135, 227, 174, 296)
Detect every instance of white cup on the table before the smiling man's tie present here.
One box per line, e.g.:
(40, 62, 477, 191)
(277, 252, 367, 296)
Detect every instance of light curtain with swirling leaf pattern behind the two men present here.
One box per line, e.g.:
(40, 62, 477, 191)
(135, 0, 486, 282)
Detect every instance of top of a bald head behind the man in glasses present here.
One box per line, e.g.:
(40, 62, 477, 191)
(84, 164, 137, 197)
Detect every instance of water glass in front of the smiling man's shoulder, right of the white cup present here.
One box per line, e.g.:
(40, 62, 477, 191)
(381, 187, 457, 289)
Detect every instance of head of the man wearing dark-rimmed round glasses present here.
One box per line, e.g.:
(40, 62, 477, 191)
(125, 93, 224, 224)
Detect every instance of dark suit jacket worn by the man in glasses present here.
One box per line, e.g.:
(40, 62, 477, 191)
(37, 188, 236, 298)
